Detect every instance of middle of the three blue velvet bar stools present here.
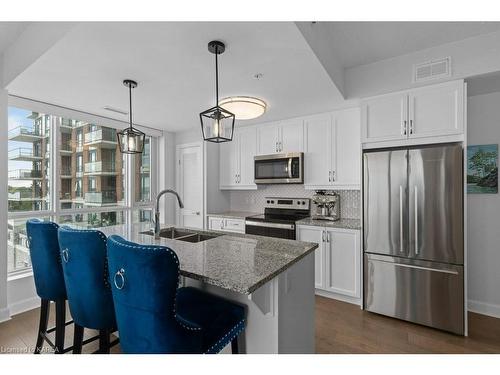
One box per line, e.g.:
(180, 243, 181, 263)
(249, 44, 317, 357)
(59, 226, 118, 354)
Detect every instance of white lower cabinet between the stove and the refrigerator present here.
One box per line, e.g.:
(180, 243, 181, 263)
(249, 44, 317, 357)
(297, 226, 361, 298)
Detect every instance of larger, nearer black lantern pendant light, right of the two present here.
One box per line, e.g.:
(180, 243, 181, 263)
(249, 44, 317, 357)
(200, 40, 235, 143)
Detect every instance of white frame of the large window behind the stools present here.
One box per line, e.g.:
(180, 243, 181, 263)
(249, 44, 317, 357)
(7, 95, 163, 279)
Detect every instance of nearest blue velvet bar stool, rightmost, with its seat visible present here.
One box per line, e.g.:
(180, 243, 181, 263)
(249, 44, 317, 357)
(108, 236, 245, 354)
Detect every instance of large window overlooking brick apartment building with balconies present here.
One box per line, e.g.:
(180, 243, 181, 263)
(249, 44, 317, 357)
(7, 101, 155, 273)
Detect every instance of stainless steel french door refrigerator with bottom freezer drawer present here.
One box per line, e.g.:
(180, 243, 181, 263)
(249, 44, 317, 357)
(363, 144, 464, 334)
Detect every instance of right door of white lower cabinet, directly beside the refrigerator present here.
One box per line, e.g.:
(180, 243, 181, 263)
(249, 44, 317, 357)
(325, 230, 361, 298)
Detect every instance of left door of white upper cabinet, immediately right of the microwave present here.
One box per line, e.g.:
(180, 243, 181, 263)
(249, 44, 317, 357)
(304, 114, 332, 189)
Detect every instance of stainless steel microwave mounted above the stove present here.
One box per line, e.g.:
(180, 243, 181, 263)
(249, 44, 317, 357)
(254, 152, 304, 184)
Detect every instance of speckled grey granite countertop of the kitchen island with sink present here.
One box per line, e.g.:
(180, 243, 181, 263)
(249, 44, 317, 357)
(99, 223, 318, 294)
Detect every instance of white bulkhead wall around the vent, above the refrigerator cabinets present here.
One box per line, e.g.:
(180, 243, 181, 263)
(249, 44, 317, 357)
(344, 32, 500, 98)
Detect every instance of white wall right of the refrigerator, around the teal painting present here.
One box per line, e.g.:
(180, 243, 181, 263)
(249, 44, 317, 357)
(467, 92, 500, 317)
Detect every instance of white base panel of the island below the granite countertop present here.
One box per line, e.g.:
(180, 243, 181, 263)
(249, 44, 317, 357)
(183, 252, 315, 354)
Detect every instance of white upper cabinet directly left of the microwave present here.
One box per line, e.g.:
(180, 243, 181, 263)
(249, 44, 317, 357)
(219, 127, 257, 190)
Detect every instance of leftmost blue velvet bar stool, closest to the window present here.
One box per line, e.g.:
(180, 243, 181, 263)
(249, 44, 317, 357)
(26, 219, 72, 354)
